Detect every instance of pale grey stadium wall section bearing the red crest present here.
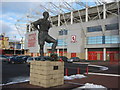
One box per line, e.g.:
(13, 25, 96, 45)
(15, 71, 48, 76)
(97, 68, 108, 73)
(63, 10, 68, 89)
(67, 24, 85, 53)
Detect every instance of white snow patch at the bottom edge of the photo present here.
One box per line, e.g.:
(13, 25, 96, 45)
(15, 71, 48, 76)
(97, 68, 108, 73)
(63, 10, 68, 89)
(73, 83, 107, 90)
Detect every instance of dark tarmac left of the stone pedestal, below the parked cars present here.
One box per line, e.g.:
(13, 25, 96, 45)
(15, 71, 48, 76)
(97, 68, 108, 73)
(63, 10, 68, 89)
(2, 62, 30, 84)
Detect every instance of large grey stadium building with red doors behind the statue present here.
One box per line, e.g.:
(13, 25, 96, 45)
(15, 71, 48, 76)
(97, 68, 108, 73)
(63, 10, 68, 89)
(25, 2, 120, 61)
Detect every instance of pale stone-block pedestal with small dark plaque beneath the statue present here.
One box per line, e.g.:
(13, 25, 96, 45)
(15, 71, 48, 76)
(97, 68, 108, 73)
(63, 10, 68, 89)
(30, 61, 64, 88)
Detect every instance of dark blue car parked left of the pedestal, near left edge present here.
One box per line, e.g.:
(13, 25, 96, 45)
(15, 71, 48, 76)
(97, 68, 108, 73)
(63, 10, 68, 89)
(8, 56, 25, 64)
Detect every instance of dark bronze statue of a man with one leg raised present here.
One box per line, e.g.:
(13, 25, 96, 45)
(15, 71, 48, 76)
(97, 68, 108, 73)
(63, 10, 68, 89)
(32, 11, 57, 56)
